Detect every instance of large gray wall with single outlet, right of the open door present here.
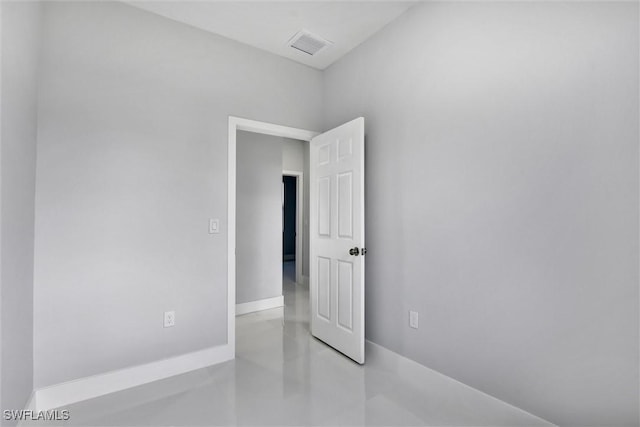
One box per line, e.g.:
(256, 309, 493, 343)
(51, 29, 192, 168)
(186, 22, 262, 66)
(324, 2, 639, 426)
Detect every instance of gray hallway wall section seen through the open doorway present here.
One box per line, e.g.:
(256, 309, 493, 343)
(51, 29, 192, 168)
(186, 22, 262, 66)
(236, 131, 282, 304)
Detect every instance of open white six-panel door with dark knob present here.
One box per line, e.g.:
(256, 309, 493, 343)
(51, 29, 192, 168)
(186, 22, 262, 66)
(309, 117, 365, 363)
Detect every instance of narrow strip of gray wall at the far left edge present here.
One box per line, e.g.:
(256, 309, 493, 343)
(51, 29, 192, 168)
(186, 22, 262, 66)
(0, 2, 41, 424)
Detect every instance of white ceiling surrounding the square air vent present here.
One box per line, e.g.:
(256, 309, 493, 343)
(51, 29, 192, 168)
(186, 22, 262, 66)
(124, 0, 417, 70)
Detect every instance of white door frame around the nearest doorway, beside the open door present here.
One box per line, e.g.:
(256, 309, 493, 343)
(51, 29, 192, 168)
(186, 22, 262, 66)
(227, 116, 319, 358)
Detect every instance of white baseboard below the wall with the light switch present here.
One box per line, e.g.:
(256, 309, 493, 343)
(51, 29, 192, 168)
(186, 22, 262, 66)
(32, 344, 235, 411)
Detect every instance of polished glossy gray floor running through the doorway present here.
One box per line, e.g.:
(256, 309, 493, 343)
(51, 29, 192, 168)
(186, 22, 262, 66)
(45, 264, 548, 426)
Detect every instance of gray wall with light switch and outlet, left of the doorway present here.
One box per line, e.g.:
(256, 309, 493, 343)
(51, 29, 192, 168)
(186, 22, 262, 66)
(34, 2, 322, 387)
